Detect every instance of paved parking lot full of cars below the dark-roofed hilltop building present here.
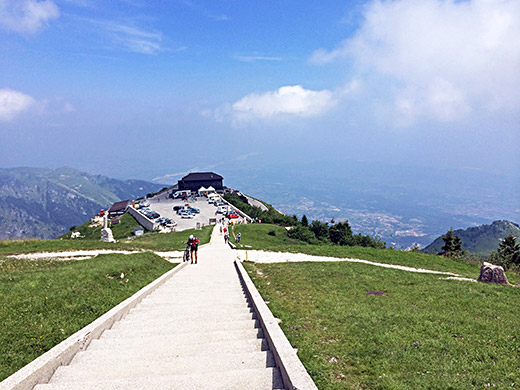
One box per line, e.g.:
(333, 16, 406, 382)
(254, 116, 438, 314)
(141, 194, 233, 231)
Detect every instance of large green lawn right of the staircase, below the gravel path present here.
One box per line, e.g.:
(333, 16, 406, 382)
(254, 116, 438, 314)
(245, 262, 520, 390)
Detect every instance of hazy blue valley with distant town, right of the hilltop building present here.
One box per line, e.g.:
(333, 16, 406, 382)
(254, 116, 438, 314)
(219, 160, 520, 249)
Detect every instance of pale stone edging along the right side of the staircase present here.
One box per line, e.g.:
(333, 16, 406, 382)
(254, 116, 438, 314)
(235, 260, 318, 390)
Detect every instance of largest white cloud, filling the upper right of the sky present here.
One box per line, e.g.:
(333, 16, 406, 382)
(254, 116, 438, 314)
(310, 0, 520, 121)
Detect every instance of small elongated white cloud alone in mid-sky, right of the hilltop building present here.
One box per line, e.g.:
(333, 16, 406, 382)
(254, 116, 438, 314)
(232, 85, 336, 120)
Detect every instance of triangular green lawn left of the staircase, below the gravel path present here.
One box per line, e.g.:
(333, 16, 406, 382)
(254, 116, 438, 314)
(0, 252, 174, 381)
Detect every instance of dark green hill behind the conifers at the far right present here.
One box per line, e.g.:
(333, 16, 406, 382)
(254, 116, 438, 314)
(422, 221, 520, 256)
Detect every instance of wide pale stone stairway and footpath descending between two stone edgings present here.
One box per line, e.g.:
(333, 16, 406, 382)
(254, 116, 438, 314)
(35, 226, 283, 390)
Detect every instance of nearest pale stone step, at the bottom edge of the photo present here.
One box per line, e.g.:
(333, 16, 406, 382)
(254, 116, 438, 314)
(34, 367, 283, 390)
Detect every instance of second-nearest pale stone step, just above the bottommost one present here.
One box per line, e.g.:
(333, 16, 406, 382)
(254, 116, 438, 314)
(55, 351, 275, 383)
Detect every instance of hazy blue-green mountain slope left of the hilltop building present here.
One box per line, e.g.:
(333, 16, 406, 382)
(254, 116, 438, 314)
(0, 168, 162, 238)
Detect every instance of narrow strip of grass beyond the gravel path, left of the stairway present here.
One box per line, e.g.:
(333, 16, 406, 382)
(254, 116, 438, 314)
(0, 226, 213, 257)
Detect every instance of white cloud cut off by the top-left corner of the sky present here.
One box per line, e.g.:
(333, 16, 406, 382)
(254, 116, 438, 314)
(0, 0, 60, 34)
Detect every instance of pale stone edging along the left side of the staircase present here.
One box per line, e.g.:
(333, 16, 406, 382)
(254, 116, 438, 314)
(0, 263, 188, 390)
